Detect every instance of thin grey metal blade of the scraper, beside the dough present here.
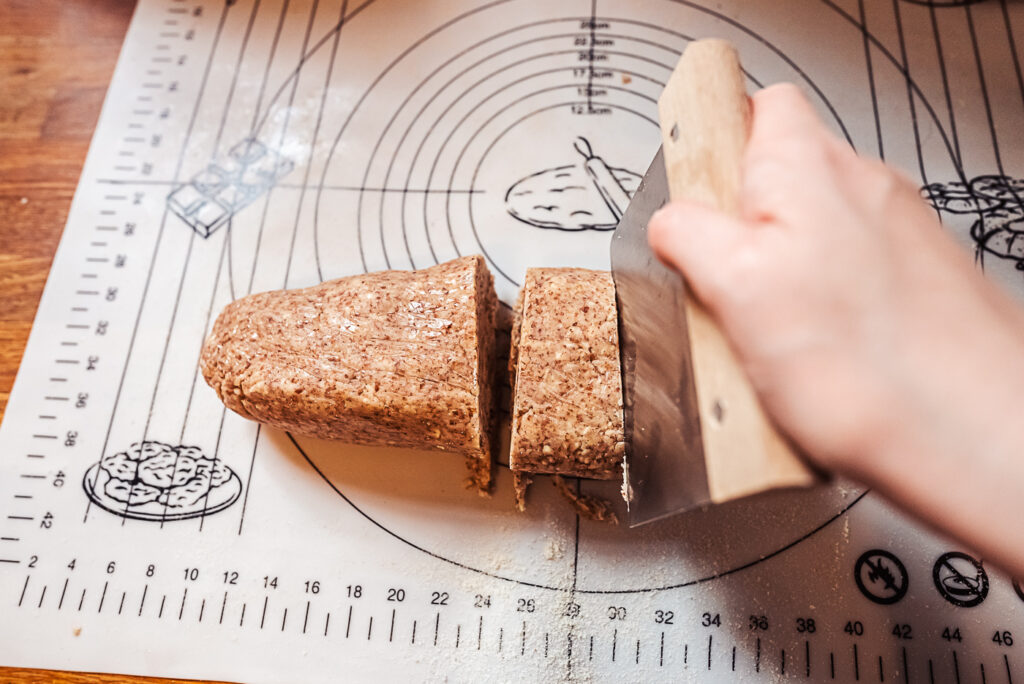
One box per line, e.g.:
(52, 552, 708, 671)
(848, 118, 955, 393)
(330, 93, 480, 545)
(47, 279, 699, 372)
(611, 149, 711, 527)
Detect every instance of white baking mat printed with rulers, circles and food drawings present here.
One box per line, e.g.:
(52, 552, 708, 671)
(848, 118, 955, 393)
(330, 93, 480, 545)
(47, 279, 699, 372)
(0, 0, 1024, 682)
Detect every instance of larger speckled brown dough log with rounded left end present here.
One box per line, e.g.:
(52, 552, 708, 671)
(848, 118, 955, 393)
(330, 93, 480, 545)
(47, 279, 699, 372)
(201, 256, 497, 493)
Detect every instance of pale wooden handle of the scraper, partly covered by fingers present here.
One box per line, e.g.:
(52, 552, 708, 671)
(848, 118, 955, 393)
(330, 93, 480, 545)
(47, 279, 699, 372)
(657, 40, 817, 502)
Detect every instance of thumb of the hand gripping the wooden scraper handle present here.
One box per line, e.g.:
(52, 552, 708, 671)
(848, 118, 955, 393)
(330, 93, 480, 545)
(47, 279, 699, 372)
(647, 202, 748, 308)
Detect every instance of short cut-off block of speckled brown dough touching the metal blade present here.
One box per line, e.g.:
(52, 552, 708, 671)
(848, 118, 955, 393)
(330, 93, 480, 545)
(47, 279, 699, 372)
(510, 268, 625, 479)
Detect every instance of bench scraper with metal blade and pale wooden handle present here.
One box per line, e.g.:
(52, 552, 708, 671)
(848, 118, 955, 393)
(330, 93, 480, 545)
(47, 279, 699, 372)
(611, 40, 818, 526)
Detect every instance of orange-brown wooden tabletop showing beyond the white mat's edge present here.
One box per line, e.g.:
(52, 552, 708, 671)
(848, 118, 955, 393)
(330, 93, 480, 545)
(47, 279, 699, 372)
(0, 0, 225, 684)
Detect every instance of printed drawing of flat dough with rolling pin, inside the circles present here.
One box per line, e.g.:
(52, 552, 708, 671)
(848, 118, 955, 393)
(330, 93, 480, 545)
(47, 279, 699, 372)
(505, 138, 641, 230)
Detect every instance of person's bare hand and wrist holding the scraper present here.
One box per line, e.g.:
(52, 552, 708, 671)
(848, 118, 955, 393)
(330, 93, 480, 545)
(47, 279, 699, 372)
(649, 85, 1024, 569)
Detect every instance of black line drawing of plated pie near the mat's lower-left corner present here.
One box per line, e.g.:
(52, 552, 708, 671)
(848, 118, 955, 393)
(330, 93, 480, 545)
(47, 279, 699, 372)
(82, 441, 242, 520)
